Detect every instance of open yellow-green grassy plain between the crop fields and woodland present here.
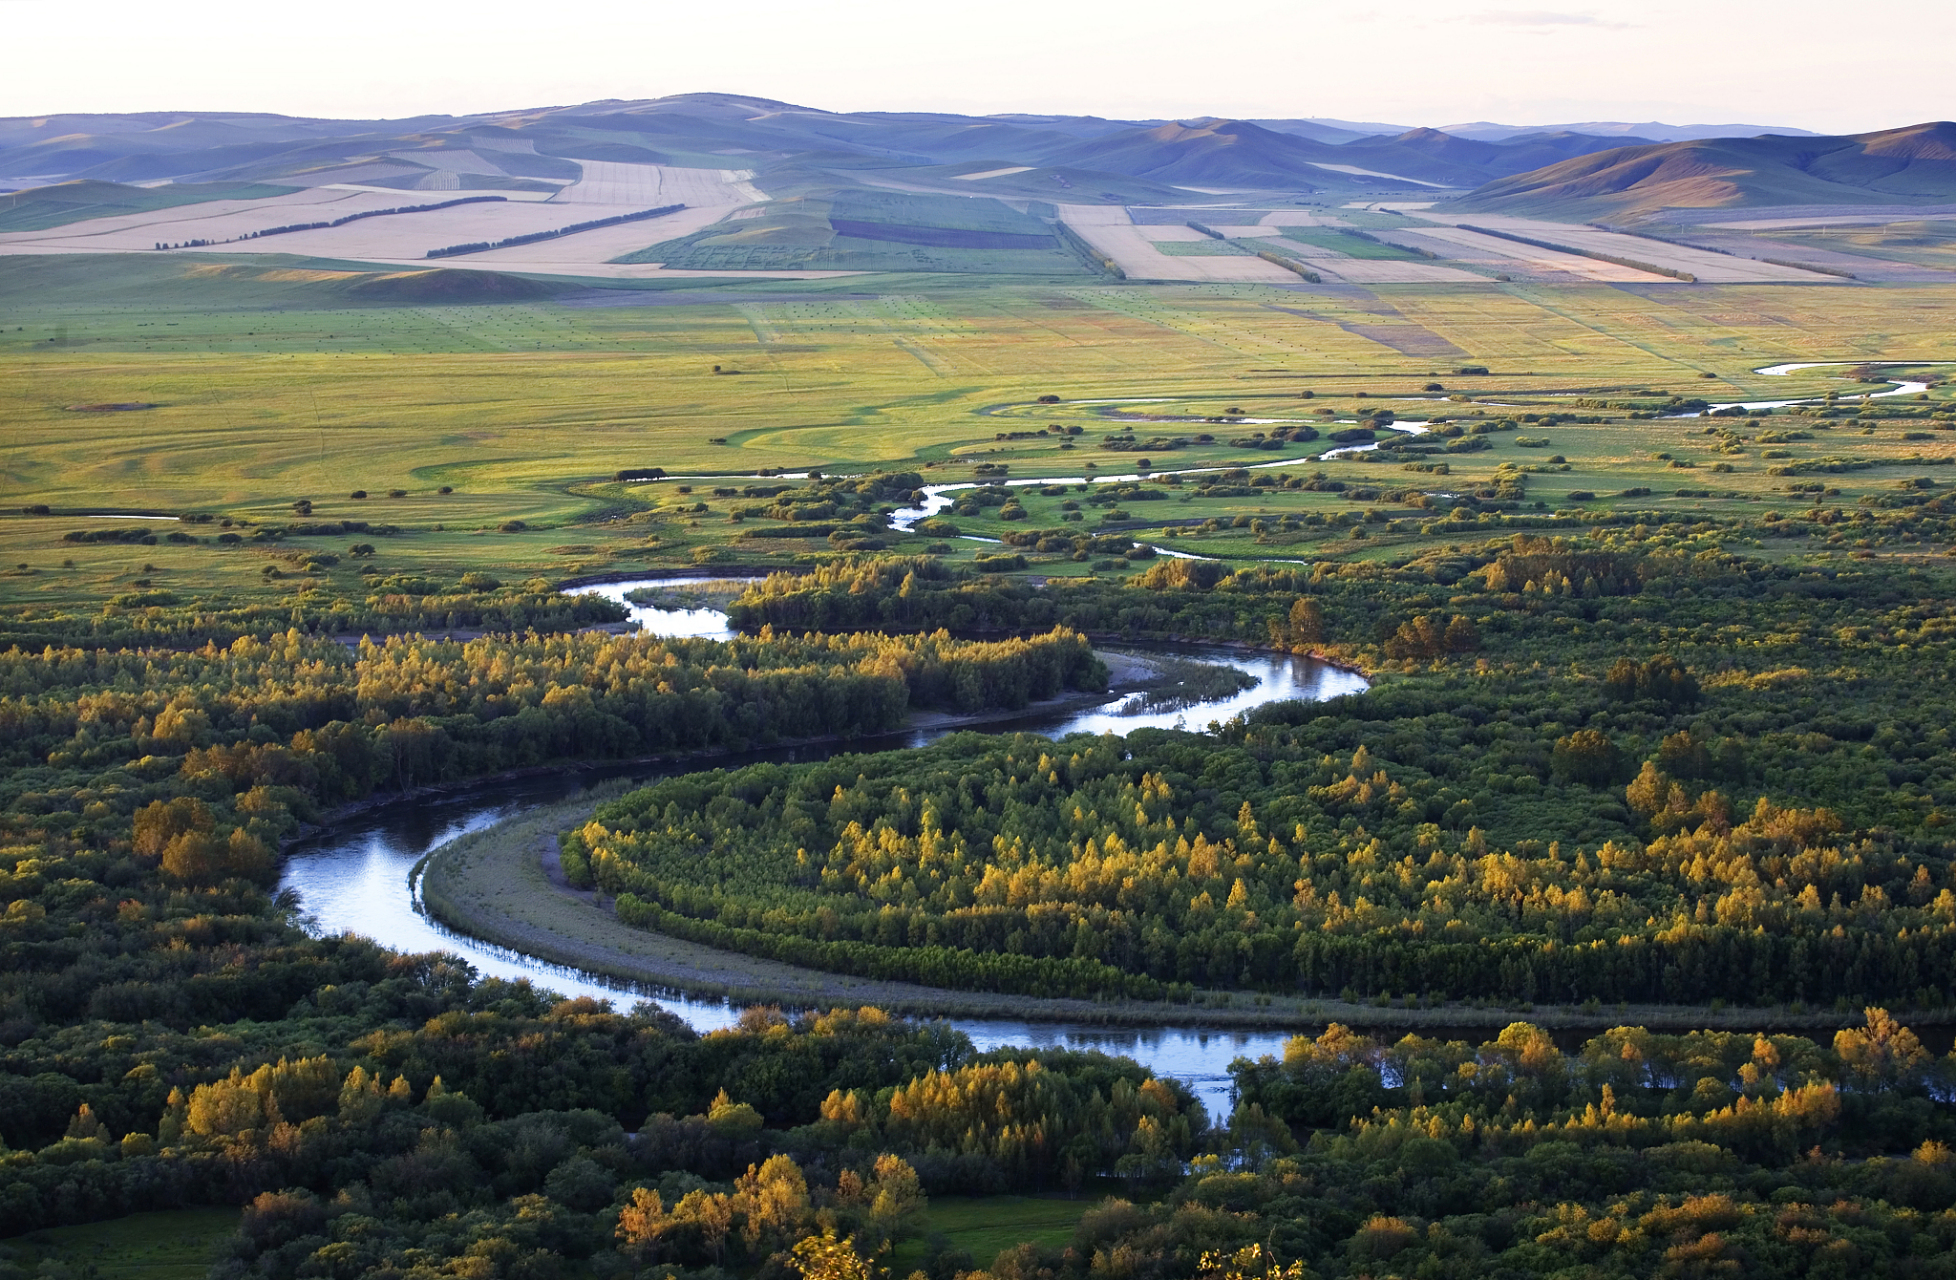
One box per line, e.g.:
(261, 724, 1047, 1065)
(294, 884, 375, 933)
(0, 252, 1956, 618)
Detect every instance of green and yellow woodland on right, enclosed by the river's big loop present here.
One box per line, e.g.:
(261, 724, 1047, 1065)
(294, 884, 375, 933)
(586, 536, 1956, 1008)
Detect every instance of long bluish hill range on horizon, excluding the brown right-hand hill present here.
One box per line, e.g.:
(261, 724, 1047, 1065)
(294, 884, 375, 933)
(0, 94, 1799, 200)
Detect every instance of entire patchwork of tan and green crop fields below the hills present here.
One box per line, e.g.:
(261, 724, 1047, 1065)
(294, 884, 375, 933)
(11, 164, 1956, 286)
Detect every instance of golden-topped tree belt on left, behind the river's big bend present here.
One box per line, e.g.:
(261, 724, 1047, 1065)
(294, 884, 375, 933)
(0, 630, 1107, 825)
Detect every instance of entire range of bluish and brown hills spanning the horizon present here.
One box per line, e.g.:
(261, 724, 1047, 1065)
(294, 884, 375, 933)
(0, 94, 1956, 217)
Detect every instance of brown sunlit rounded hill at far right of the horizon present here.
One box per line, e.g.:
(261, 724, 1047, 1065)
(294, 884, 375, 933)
(1457, 121, 1956, 221)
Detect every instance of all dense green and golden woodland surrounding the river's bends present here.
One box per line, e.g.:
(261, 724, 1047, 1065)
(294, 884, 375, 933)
(0, 516, 1956, 1280)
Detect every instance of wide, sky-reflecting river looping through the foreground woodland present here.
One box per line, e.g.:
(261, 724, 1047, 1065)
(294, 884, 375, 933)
(280, 579, 1365, 1116)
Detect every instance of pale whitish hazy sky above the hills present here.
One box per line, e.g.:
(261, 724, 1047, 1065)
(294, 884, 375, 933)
(0, 0, 1956, 133)
